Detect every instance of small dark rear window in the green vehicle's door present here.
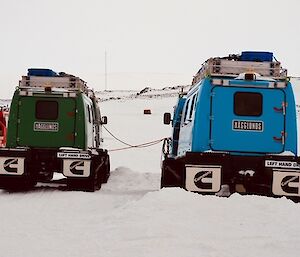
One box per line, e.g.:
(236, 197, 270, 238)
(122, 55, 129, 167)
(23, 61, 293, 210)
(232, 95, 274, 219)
(35, 100, 58, 120)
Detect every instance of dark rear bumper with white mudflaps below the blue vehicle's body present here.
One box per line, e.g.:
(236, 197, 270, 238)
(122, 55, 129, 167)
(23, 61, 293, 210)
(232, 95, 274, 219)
(163, 153, 300, 197)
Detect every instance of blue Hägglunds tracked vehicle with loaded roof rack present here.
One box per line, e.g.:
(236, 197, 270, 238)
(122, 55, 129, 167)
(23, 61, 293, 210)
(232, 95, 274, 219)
(161, 52, 300, 199)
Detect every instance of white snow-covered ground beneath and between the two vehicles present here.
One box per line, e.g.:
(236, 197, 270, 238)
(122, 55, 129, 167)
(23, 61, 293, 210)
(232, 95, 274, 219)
(0, 87, 300, 257)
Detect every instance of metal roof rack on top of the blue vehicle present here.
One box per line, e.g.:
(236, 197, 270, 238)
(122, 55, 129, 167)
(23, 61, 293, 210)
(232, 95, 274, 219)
(192, 55, 287, 85)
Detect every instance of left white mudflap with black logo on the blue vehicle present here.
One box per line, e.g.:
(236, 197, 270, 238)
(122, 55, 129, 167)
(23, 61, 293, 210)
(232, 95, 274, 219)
(185, 165, 221, 193)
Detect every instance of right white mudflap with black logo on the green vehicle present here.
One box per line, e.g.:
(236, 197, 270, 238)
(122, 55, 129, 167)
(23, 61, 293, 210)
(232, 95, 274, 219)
(63, 159, 91, 177)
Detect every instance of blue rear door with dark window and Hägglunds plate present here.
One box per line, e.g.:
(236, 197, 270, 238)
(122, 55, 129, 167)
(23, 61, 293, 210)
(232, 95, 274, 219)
(210, 86, 285, 153)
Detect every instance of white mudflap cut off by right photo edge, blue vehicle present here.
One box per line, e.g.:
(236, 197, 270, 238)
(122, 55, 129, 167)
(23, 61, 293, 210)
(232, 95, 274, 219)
(272, 169, 300, 196)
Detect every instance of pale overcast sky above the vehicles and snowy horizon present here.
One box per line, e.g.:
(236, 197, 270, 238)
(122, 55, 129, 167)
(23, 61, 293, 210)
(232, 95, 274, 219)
(0, 0, 300, 98)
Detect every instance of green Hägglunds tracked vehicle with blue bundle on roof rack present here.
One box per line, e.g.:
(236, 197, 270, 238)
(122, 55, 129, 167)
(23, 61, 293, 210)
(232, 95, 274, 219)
(0, 69, 110, 192)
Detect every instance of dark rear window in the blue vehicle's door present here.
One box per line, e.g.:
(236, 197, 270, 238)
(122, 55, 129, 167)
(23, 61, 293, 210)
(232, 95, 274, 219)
(234, 92, 263, 116)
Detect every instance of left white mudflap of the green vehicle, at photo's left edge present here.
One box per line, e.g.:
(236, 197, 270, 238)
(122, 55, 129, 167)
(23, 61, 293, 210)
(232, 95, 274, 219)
(0, 157, 25, 176)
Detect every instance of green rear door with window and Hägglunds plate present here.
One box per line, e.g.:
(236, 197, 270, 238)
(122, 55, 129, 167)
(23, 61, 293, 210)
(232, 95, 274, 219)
(17, 96, 76, 147)
